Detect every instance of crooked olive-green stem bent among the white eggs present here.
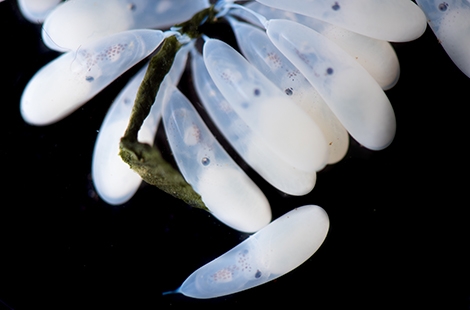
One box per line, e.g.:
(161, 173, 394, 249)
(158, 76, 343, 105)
(119, 6, 225, 210)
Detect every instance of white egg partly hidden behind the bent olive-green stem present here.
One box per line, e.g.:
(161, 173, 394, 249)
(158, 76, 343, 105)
(92, 43, 192, 205)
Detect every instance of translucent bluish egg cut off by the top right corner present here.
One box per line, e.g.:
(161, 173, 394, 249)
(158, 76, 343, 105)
(416, 0, 470, 77)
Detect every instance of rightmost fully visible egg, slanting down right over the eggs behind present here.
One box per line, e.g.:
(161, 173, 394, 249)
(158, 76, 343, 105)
(267, 19, 396, 150)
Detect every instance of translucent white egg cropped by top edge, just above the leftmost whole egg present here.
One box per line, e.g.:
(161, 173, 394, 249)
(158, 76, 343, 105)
(42, 0, 209, 51)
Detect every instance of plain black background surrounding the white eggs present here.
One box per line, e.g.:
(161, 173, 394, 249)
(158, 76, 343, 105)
(0, 0, 470, 309)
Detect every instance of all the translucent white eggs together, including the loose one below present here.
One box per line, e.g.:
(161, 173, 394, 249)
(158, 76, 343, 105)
(19, 0, 470, 298)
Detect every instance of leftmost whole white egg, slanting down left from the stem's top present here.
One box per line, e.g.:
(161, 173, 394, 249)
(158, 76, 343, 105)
(20, 30, 164, 125)
